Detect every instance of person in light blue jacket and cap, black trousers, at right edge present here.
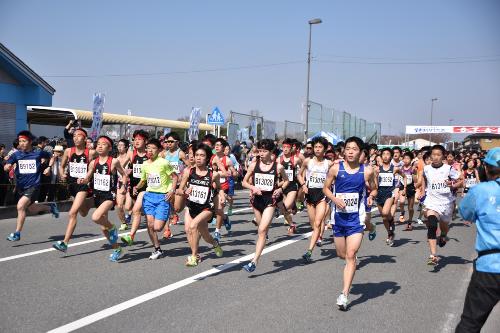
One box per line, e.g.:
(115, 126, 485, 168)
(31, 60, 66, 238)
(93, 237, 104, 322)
(455, 147, 500, 333)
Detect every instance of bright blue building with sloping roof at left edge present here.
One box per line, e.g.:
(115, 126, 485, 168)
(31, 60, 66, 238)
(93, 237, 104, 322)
(0, 43, 55, 148)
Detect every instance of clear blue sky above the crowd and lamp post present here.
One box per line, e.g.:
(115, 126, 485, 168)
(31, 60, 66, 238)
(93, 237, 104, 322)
(0, 0, 500, 134)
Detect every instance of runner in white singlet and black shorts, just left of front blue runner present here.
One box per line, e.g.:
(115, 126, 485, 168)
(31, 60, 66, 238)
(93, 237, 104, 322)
(298, 137, 333, 263)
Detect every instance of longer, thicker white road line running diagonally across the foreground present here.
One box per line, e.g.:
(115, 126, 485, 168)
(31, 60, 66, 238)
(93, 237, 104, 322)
(48, 232, 312, 333)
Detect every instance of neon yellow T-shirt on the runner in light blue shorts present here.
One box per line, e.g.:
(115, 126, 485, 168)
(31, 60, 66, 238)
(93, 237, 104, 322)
(141, 158, 175, 193)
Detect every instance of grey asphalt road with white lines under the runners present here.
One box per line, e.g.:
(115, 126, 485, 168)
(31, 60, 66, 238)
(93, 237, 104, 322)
(0, 191, 500, 332)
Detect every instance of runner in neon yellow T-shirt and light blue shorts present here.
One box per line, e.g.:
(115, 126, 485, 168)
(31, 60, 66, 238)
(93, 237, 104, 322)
(133, 139, 177, 260)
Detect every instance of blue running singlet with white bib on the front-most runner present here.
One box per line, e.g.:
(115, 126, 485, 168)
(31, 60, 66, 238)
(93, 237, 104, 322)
(334, 162, 366, 226)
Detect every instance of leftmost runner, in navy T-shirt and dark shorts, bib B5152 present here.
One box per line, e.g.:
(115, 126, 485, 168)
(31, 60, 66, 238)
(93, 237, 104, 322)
(4, 131, 59, 242)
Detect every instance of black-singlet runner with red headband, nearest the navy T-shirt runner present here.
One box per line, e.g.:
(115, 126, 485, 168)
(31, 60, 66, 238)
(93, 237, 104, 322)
(52, 128, 96, 252)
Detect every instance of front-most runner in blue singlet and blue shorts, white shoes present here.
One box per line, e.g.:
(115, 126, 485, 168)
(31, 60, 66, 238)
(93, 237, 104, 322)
(323, 137, 377, 310)
